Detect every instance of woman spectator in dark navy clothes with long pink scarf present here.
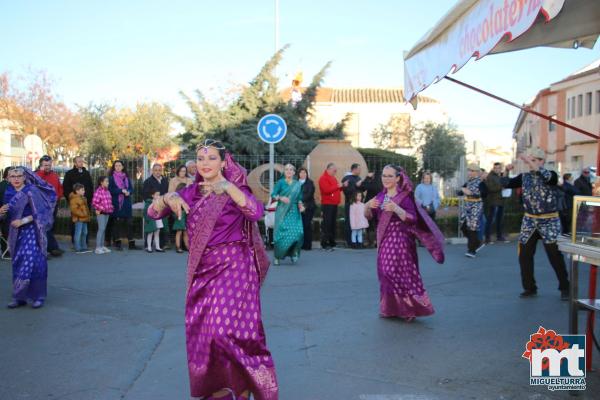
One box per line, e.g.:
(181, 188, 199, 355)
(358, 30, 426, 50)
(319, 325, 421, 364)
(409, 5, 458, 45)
(108, 160, 140, 251)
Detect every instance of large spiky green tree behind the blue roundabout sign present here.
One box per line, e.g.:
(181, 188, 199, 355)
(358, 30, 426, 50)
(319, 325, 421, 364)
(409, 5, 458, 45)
(176, 46, 345, 155)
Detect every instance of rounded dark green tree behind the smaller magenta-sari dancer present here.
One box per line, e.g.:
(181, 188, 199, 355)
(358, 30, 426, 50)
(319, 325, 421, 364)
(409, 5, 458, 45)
(412, 122, 466, 178)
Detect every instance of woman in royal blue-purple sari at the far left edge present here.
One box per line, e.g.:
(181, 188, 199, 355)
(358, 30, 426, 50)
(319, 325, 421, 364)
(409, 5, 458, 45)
(3, 167, 56, 308)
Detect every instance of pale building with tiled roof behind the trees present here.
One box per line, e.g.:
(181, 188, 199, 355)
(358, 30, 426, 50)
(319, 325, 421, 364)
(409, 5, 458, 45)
(281, 87, 448, 153)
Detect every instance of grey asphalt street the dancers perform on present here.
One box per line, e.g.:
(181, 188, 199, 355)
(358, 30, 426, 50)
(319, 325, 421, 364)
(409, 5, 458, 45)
(0, 239, 600, 400)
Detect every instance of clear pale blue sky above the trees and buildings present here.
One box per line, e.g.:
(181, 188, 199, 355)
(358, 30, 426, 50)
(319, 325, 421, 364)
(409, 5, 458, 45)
(0, 0, 600, 146)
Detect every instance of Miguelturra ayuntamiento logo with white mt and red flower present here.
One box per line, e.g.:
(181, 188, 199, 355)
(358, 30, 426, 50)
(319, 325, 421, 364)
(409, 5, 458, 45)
(522, 326, 585, 391)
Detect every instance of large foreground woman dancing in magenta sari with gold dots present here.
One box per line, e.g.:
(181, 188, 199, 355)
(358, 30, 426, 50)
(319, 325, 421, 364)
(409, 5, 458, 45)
(148, 139, 278, 400)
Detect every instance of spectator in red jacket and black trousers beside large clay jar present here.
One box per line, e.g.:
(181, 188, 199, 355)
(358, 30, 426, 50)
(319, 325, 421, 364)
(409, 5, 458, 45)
(319, 163, 348, 251)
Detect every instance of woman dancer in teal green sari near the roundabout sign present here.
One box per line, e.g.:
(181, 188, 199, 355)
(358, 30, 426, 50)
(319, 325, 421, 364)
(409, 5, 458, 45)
(271, 164, 304, 265)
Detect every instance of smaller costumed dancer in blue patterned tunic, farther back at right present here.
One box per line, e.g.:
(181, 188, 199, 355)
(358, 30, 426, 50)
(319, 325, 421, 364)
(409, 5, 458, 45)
(458, 163, 483, 258)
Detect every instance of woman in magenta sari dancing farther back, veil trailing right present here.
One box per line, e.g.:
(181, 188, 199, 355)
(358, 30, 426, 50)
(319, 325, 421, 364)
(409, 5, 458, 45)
(365, 165, 444, 321)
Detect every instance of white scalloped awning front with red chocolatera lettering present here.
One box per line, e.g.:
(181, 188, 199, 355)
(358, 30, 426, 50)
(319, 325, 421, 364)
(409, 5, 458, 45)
(404, 0, 564, 101)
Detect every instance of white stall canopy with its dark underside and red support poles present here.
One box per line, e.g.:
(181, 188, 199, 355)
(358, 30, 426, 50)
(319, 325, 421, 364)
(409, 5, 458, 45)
(404, 0, 600, 370)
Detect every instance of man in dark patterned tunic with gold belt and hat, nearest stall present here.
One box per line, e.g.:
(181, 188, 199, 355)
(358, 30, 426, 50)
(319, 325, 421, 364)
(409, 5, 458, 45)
(502, 147, 569, 300)
